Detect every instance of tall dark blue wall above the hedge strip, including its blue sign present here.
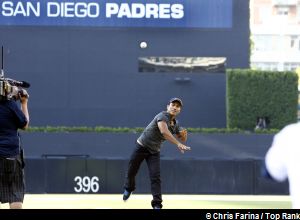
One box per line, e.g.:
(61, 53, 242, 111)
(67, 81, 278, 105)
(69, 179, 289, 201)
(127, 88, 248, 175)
(0, 0, 249, 127)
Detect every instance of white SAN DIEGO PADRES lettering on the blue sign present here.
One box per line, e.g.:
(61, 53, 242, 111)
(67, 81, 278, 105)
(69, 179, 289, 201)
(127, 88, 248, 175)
(0, 0, 184, 20)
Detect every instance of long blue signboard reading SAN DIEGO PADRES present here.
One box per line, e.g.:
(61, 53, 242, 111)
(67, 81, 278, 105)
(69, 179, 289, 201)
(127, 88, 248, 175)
(0, 0, 232, 28)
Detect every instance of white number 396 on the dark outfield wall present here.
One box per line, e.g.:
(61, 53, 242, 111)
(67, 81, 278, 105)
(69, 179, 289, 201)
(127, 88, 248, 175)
(74, 176, 99, 193)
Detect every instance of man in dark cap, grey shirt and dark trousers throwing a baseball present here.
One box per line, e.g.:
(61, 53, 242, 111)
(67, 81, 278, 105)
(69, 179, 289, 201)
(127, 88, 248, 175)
(123, 98, 191, 209)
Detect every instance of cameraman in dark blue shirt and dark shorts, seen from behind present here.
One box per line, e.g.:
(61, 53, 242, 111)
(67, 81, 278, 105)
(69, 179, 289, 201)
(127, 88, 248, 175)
(0, 89, 29, 209)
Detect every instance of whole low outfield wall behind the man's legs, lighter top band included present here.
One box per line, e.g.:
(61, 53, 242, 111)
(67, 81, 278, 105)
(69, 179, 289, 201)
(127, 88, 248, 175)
(22, 133, 288, 195)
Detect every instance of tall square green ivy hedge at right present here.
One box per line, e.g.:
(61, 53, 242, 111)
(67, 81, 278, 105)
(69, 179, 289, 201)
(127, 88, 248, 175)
(226, 69, 298, 130)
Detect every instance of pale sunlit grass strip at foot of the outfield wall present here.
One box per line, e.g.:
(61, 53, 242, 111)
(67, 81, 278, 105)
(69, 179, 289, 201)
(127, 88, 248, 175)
(1, 194, 291, 209)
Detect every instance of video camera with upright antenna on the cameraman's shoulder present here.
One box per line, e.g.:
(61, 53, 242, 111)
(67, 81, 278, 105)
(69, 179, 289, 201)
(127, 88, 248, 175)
(0, 46, 30, 100)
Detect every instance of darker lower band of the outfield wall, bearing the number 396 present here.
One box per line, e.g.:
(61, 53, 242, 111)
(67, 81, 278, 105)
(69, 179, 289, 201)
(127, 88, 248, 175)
(26, 156, 288, 195)
